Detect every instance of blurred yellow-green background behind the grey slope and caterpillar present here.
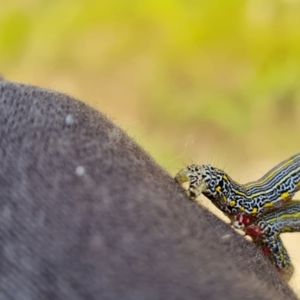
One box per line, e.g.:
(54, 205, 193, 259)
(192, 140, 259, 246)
(0, 0, 300, 291)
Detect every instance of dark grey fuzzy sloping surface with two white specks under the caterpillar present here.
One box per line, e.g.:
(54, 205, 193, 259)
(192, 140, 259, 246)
(0, 80, 296, 300)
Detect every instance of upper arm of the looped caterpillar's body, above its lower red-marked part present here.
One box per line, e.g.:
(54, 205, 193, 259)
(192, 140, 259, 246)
(175, 153, 300, 229)
